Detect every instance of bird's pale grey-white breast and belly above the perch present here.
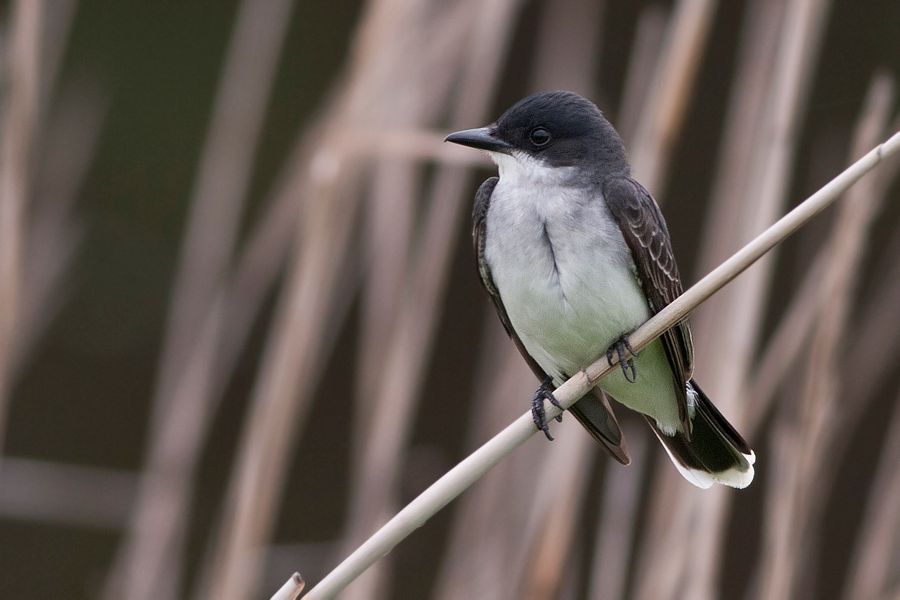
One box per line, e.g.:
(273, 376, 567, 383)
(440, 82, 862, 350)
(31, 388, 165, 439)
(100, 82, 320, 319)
(485, 177, 648, 369)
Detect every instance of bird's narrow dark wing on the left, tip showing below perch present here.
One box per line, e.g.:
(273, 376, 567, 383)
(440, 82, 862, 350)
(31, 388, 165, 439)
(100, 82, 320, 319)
(472, 177, 631, 465)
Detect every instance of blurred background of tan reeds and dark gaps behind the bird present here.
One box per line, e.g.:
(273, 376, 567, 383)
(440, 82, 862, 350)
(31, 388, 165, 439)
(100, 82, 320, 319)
(0, 0, 900, 600)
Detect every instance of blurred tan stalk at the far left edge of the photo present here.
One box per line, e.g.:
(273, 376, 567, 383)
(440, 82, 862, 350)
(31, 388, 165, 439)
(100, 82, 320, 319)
(0, 0, 45, 450)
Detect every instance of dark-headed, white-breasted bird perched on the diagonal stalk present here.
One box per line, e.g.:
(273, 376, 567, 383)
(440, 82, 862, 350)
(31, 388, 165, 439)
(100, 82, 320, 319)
(446, 91, 756, 488)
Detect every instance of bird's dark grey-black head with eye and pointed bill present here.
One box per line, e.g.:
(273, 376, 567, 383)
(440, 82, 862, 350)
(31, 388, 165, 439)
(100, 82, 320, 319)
(447, 92, 629, 176)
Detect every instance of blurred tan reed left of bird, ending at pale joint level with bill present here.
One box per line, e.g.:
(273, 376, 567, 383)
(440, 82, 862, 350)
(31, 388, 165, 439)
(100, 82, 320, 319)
(198, 146, 364, 598)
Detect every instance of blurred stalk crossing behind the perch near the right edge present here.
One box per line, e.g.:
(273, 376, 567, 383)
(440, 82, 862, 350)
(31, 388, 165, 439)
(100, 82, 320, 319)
(760, 76, 893, 598)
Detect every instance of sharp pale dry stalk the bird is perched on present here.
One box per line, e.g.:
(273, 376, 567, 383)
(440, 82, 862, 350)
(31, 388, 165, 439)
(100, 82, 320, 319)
(305, 132, 900, 600)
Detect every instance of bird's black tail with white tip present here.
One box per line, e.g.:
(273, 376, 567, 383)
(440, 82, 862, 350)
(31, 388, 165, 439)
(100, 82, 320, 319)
(647, 379, 756, 488)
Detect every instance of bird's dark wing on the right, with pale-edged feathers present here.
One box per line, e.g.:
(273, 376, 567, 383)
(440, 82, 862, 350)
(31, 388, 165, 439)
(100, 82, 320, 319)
(603, 177, 694, 435)
